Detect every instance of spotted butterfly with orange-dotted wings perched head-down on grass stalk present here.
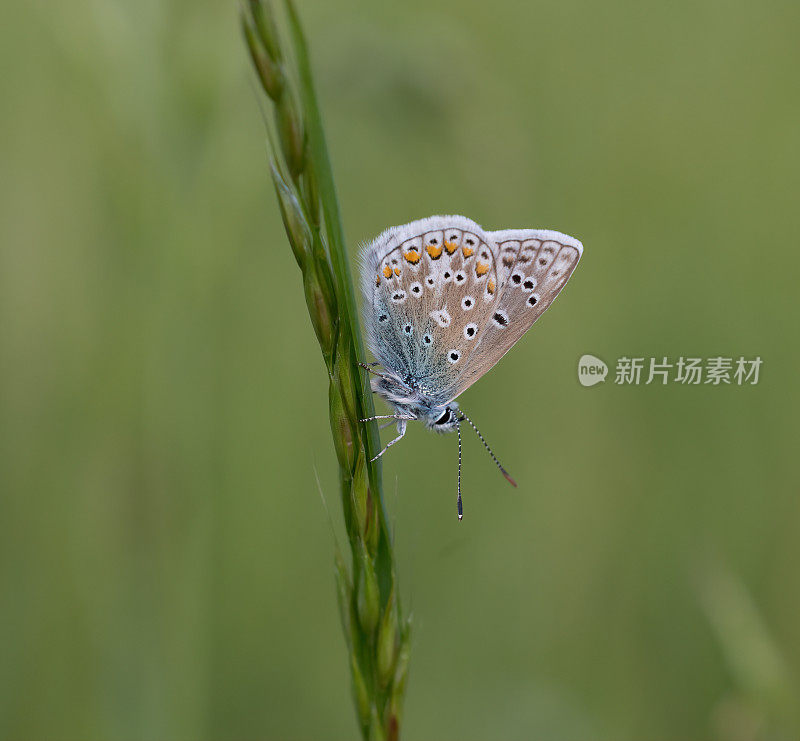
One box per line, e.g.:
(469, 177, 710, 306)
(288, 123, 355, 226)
(361, 216, 583, 520)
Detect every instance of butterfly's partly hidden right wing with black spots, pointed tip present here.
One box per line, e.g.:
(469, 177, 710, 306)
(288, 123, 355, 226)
(448, 229, 583, 399)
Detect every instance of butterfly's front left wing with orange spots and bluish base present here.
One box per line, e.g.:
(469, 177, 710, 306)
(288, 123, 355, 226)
(362, 216, 501, 404)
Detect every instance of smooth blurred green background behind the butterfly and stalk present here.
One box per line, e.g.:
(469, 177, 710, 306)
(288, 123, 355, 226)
(0, 0, 800, 741)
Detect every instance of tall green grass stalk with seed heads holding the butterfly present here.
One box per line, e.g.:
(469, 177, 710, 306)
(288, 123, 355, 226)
(241, 0, 410, 741)
